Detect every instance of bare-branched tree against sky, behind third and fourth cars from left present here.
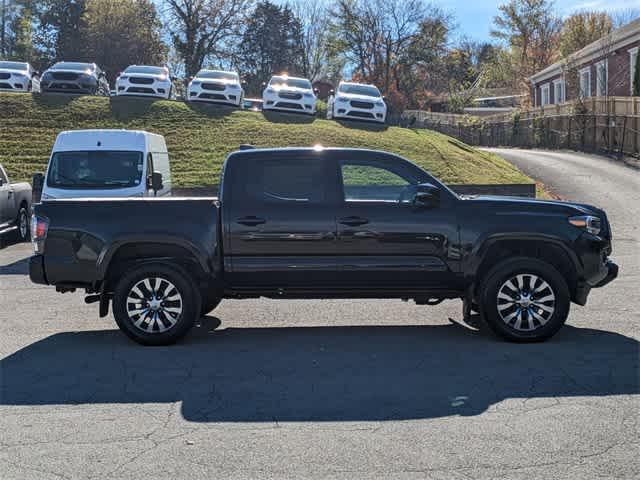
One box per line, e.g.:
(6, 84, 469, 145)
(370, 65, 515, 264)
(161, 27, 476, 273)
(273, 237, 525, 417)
(166, 0, 253, 78)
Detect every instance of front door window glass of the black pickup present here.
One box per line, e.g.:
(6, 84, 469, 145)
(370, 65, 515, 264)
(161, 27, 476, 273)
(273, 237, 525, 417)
(341, 162, 418, 203)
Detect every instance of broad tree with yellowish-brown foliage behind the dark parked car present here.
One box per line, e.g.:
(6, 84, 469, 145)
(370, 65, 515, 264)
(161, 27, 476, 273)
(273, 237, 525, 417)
(80, 0, 167, 79)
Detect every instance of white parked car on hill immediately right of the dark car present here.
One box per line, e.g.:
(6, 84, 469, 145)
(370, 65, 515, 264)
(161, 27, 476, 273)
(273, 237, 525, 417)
(116, 65, 173, 99)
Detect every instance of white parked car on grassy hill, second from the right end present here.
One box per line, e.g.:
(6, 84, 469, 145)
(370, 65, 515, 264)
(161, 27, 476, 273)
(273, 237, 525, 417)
(262, 75, 318, 115)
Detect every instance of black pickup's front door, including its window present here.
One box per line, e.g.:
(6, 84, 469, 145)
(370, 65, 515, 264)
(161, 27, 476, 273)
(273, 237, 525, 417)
(336, 152, 459, 288)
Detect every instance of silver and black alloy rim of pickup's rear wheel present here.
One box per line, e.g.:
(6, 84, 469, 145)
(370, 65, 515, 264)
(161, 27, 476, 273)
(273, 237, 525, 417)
(127, 277, 183, 333)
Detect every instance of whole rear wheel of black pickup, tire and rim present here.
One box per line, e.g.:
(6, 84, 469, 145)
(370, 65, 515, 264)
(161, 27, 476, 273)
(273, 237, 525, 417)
(113, 263, 202, 345)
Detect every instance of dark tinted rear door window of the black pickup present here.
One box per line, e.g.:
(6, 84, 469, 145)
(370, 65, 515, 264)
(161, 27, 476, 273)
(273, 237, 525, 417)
(234, 158, 326, 203)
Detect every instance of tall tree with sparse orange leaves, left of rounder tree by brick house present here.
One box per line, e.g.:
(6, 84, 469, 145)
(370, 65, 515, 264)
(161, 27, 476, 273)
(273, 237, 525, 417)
(491, 0, 561, 90)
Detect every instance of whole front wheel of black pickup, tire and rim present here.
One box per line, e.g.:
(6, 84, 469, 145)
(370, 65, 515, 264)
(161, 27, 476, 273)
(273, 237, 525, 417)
(477, 257, 571, 343)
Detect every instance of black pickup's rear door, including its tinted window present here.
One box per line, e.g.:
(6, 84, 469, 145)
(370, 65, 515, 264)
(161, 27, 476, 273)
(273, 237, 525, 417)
(222, 151, 337, 289)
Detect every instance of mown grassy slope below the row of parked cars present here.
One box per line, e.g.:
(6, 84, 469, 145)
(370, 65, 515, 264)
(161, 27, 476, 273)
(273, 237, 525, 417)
(0, 94, 531, 187)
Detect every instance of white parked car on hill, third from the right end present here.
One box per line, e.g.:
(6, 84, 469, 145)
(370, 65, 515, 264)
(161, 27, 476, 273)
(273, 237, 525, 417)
(187, 69, 244, 107)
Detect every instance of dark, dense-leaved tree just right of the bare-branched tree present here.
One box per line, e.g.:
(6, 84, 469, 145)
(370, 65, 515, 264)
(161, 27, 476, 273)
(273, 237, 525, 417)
(236, 1, 305, 93)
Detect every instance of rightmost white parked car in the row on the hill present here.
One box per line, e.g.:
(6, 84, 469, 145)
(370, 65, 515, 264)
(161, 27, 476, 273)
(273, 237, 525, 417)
(327, 82, 387, 123)
